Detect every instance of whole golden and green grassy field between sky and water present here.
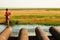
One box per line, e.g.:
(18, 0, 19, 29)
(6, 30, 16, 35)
(0, 9, 60, 25)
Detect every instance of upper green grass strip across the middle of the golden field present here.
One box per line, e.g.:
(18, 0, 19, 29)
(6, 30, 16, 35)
(11, 15, 60, 19)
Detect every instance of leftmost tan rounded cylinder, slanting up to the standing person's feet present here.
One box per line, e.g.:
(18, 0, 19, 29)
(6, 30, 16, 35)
(0, 27, 12, 40)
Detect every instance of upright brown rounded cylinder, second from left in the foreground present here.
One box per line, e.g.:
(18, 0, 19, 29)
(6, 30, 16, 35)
(18, 28, 29, 40)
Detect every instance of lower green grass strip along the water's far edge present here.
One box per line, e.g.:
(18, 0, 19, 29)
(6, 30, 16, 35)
(10, 20, 60, 26)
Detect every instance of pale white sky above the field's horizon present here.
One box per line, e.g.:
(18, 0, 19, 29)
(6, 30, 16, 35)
(0, 0, 60, 8)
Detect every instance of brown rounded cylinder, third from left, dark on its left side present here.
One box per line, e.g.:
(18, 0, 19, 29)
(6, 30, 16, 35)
(35, 27, 50, 40)
